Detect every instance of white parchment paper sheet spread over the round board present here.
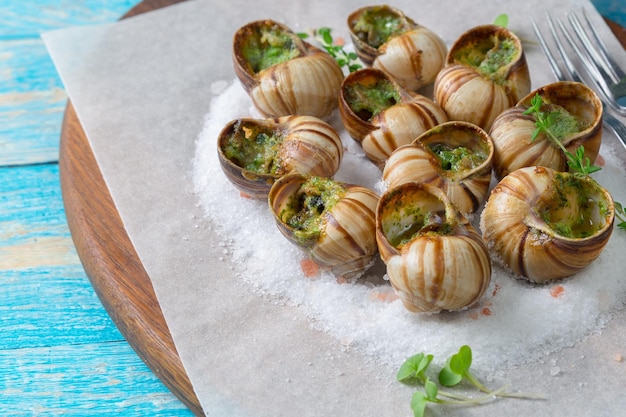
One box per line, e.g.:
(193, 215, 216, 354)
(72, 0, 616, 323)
(44, 0, 626, 417)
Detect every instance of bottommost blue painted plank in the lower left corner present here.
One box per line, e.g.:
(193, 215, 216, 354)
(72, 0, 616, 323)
(0, 342, 191, 417)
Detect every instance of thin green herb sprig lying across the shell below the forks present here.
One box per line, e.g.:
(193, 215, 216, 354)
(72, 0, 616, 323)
(524, 94, 601, 177)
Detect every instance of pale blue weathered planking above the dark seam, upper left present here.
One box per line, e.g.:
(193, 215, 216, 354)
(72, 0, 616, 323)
(0, 0, 137, 166)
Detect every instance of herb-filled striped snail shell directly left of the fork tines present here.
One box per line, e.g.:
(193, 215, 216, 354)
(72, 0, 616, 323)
(434, 25, 530, 131)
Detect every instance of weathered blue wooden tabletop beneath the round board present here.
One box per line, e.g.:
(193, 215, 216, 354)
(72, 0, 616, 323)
(0, 0, 626, 416)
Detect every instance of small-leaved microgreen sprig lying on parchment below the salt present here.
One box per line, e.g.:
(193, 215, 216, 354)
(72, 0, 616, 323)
(397, 345, 542, 417)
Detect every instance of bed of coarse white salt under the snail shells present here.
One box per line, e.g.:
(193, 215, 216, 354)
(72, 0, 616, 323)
(193, 80, 626, 372)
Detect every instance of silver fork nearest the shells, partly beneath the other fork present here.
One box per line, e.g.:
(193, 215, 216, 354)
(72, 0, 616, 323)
(531, 12, 626, 148)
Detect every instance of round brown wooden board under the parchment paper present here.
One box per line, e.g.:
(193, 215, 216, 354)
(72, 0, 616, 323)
(59, 0, 626, 415)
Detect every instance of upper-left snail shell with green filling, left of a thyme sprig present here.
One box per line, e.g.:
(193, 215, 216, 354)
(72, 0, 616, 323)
(233, 20, 343, 118)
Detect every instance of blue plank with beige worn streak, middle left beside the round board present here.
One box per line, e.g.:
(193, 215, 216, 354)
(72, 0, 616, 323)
(0, 164, 117, 349)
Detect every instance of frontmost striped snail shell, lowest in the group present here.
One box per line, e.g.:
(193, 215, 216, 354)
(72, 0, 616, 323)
(376, 182, 491, 312)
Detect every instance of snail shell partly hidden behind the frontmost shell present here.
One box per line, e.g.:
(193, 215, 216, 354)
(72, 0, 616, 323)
(383, 122, 494, 215)
